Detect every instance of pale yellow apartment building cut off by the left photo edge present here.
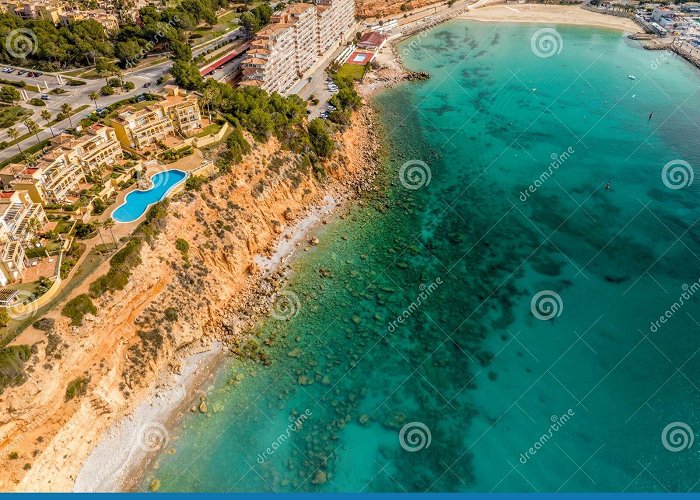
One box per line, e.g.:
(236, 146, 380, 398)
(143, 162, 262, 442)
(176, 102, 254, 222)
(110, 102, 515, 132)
(0, 190, 47, 286)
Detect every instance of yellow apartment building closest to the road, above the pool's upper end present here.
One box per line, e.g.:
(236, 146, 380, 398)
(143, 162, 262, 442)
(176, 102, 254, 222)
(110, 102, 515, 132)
(112, 85, 202, 149)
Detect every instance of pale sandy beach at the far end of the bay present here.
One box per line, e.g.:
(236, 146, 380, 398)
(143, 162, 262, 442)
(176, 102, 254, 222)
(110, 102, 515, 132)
(458, 4, 641, 33)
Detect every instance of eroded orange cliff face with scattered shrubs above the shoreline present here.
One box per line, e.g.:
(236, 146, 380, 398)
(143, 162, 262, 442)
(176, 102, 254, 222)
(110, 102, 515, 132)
(0, 108, 376, 491)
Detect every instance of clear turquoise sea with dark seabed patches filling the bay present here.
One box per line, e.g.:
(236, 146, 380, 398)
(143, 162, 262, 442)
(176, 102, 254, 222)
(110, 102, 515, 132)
(142, 21, 700, 492)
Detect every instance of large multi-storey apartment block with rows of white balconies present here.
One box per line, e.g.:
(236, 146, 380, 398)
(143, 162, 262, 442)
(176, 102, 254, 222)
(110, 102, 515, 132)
(241, 0, 355, 94)
